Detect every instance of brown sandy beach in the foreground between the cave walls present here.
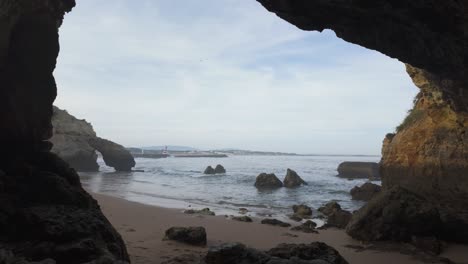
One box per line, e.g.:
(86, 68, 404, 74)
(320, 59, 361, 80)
(91, 193, 468, 264)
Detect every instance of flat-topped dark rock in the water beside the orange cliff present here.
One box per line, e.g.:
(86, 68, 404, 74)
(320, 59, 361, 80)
(337, 161, 380, 180)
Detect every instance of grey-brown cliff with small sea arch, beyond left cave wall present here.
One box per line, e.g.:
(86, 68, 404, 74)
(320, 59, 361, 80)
(50, 107, 135, 171)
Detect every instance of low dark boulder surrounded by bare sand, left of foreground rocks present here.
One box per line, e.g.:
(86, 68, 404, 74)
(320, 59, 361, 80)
(163, 227, 206, 246)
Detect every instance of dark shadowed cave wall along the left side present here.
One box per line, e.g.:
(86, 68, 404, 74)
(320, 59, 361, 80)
(0, 0, 129, 263)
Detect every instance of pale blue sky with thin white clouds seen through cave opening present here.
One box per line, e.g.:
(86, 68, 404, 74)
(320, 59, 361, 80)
(55, 0, 417, 155)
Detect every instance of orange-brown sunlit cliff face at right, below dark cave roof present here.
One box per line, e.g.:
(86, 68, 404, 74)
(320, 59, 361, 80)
(382, 65, 468, 204)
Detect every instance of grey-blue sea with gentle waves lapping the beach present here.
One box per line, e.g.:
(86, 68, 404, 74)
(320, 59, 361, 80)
(80, 156, 380, 219)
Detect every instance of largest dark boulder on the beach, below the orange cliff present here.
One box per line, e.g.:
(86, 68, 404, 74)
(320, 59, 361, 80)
(346, 187, 448, 242)
